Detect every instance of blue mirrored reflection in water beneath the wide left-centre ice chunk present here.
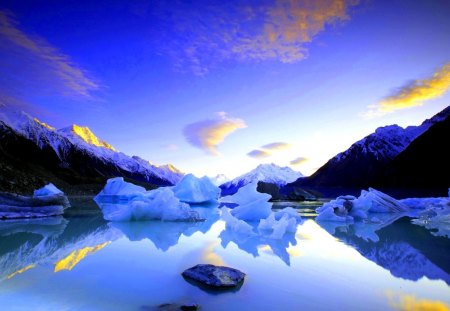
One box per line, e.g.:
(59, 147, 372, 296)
(110, 207, 219, 252)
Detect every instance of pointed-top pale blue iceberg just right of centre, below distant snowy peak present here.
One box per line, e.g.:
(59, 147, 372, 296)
(221, 182, 272, 221)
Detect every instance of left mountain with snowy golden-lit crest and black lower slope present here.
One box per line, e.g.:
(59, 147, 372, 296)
(0, 113, 184, 193)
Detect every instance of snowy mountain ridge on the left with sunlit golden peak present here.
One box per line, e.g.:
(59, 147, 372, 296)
(0, 113, 184, 194)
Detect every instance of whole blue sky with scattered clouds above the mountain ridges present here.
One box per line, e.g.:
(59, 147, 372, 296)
(0, 0, 450, 178)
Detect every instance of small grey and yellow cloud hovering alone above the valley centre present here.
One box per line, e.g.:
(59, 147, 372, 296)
(183, 112, 247, 155)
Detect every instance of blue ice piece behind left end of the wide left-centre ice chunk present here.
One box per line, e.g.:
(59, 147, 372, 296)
(94, 177, 147, 202)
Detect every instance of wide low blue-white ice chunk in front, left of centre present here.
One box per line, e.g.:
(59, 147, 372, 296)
(99, 187, 201, 221)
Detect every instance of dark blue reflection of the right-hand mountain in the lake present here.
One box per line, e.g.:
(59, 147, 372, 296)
(326, 217, 450, 284)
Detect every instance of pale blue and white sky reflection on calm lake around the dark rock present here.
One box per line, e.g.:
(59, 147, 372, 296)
(0, 218, 450, 310)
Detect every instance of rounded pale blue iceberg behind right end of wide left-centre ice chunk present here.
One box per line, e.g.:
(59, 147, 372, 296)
(172, 174, 220, 204)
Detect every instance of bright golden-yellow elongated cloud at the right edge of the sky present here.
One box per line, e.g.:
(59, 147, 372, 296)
(366, 63, 450, 117)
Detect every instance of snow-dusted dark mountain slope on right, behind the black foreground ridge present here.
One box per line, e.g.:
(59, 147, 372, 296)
(290, 106, 450, 196)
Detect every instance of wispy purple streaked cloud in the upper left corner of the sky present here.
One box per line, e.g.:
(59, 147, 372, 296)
(0, 10, 100, 106)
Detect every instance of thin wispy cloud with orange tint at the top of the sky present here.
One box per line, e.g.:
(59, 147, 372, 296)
(153, 0, 359, 75)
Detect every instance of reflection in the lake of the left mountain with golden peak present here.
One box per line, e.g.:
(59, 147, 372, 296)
(0, 217, 120, 281)
